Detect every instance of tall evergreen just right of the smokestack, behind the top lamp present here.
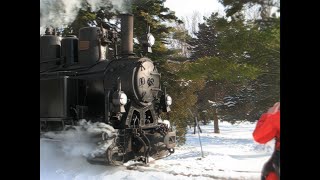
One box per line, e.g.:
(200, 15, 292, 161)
(131, 0, 182, 62)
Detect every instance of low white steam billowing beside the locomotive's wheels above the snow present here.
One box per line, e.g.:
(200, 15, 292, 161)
(40, 120, 117, 158)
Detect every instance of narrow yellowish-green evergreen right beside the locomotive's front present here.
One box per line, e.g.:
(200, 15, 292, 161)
(162, 62, 205, 145)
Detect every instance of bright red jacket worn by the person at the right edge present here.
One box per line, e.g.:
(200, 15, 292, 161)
(253, 111, 280, 151)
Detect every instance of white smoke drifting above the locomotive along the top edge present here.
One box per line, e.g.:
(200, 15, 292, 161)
(40, 0, 128, 34)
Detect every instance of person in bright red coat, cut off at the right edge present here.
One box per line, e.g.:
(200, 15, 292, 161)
(253, 102, 280, 180)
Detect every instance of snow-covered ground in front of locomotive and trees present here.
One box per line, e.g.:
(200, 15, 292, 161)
(40, 122, 274, 180)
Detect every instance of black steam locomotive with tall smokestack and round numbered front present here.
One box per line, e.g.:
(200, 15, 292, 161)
(40, 14, 176, 165)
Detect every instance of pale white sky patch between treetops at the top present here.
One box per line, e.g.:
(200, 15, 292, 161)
(164, 0, 224, 18)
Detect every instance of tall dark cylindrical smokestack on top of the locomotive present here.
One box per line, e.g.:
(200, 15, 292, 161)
(120, 14, 133, 55)
